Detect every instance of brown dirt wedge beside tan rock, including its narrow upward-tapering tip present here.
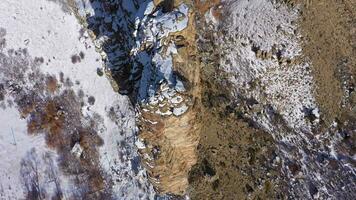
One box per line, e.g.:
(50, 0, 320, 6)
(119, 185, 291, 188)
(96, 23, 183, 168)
(188, 4, 283, 199)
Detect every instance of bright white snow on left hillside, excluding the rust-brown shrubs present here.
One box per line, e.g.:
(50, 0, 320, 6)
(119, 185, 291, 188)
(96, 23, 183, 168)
(0, 0, 154, 199)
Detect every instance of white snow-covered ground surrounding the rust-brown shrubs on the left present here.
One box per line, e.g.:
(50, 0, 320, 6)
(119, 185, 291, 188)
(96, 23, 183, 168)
(0, 0, 154, 199)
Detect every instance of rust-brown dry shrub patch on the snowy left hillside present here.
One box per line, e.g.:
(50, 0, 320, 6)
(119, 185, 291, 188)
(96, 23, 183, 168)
(27, 87, 107, 199)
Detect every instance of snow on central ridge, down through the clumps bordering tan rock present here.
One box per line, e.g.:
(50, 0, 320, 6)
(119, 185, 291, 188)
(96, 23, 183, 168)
(133, 4, 188, 116)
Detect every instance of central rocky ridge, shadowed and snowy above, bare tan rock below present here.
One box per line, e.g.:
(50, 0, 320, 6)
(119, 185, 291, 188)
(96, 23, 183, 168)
(71, 1, 200, 195)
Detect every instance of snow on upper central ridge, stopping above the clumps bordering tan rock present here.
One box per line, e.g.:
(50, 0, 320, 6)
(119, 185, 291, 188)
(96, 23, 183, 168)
(133, 4, 188, 101)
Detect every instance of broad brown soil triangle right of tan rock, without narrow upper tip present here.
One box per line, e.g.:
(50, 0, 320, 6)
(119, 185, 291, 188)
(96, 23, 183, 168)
(189, 75, 278, 199)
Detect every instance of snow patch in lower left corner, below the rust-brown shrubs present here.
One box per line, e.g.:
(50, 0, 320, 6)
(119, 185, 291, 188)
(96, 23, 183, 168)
(0, 101, 73, 199)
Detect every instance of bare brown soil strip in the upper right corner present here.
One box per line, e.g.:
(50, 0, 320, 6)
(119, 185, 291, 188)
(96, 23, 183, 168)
(291, 0, 356, 126)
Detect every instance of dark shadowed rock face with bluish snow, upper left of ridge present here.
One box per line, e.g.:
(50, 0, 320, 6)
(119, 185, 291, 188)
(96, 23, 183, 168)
(87, 0, 188, 102)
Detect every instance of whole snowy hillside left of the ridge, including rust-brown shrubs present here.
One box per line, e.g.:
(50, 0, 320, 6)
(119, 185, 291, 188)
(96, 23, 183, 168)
(0, 0, 154, 199)
